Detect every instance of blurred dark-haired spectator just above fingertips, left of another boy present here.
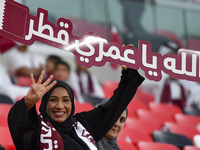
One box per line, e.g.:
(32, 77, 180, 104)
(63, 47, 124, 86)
(43, 55, 62, 81)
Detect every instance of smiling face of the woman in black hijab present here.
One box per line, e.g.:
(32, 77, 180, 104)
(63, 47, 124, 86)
(46, 87, 72, 123)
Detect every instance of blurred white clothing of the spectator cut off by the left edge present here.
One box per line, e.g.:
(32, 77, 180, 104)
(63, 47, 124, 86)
(0, 62, 29, 103)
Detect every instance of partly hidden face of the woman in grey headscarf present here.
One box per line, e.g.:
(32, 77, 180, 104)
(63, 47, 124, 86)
(106, 110, 126, 139)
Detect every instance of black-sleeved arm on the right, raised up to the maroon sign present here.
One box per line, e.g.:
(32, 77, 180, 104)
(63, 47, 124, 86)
(76, 66, 144, 142)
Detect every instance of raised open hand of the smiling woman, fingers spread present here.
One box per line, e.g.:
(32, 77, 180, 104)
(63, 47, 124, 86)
(24, 71, 56, 110)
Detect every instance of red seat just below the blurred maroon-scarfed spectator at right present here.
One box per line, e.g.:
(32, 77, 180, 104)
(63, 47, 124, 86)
(149, 102, 183, 117)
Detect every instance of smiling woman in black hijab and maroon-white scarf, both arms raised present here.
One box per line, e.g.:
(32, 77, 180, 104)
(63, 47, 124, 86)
(8, 66, 144, 150)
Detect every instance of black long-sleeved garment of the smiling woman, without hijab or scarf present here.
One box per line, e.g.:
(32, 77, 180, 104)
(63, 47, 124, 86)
(8, 68, 144, 150)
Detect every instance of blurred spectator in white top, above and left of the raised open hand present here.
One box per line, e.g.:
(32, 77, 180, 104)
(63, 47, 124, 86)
(3, 43, 45, 83)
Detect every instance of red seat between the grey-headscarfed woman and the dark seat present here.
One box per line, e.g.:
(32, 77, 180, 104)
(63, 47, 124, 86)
(118, 128, 153, 144)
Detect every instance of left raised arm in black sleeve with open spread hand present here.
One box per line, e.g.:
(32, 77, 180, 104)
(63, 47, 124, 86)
(8, 71, 56, 149)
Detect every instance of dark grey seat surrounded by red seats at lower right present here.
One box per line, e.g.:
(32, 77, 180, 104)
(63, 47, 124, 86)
(152, 130, 193, 149)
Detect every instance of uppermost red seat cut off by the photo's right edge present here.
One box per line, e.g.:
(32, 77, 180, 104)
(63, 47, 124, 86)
(174, 114, 200, 130)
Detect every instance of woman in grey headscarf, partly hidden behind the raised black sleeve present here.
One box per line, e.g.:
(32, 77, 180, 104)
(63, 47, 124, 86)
(97, 99, 128, 150)
